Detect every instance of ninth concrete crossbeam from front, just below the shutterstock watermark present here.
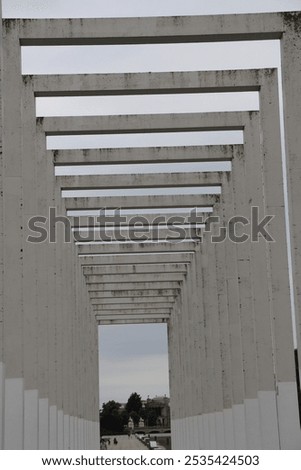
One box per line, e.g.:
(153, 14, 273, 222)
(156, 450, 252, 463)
(77, 241, 200, 256)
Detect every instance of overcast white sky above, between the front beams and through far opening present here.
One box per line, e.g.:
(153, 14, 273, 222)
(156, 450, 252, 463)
(2, 0, 301, 403)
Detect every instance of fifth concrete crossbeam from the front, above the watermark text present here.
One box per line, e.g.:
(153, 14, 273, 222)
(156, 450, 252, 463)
(56, 171, 225, 191)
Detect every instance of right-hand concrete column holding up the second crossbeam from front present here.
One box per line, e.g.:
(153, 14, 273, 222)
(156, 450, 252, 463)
(254, 70, 301, 449)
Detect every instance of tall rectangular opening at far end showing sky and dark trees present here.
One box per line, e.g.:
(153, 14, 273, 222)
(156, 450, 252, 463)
(99, 324, 170, 449)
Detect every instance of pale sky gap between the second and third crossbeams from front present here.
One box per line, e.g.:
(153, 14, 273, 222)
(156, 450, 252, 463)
(36, 92, 259, 117)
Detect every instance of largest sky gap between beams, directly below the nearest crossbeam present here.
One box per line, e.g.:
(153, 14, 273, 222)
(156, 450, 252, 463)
(21, 40, 279, 75)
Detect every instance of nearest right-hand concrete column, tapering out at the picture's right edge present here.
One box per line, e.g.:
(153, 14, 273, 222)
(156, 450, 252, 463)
(281, 12, 301, 378)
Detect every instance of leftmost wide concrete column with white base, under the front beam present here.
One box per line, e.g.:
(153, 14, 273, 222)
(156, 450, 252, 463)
(2, 20, 24, 449)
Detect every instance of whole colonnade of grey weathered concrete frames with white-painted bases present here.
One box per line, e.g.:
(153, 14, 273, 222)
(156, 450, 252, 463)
(0, 12, 301, 449)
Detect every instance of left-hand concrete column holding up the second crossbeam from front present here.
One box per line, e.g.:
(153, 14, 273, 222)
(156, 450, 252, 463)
(21, 78, 39, 449)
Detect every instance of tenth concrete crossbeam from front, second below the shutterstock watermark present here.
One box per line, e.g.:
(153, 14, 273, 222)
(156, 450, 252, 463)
(78, 252, 193, 267)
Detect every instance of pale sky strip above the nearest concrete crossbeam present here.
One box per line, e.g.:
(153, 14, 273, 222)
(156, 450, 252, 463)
(2, 0, 300, 18)
